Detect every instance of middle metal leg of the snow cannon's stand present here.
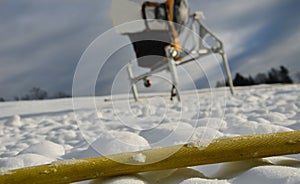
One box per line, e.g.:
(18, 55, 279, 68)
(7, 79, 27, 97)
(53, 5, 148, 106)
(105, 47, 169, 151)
(166, 48, 181, 102)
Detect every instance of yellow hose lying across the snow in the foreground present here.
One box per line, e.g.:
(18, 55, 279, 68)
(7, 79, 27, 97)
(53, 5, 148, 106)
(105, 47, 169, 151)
(0, 131, 300, 184)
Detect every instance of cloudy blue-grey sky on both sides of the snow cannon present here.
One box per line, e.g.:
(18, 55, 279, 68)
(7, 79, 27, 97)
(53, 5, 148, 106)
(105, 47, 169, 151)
(0, 0, 300, 98)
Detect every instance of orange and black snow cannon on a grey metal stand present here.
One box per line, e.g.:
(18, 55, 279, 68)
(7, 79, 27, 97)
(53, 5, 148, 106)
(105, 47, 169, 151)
(111, 0, 233, 101)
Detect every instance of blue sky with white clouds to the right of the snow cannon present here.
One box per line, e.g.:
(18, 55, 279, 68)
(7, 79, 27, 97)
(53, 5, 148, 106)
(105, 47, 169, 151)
(189, 0, 300, 79)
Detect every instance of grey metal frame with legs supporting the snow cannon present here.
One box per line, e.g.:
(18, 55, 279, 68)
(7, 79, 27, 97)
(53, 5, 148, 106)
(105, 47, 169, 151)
(127, 12, 234, 101)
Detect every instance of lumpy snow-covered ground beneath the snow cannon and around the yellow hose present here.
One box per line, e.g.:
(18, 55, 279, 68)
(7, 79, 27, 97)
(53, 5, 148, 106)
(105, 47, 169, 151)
(0, 85, 300, 184)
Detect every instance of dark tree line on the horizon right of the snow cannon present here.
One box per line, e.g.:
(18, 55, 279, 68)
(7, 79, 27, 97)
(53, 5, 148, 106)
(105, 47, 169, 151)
(216, 66, 300, 87)
